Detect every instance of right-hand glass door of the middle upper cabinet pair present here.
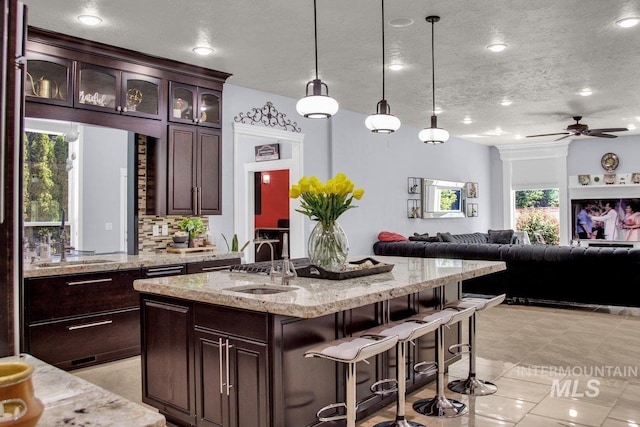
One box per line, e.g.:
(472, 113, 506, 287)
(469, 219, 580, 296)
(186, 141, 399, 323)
(121, 73, 161, 118)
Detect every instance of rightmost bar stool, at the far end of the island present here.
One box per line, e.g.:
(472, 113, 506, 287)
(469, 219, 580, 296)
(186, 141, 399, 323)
(448, 294, 506, 396)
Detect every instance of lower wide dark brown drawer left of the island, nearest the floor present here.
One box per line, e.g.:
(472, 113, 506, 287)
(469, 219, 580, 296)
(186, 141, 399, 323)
(26, 308, 140, 369)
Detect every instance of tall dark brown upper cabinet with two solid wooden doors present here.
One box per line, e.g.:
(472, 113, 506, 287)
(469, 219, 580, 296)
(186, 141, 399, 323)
(167, 125, 222, 215)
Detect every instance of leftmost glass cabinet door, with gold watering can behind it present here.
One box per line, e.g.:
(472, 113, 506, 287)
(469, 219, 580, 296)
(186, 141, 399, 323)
(24, 53, 73, 106)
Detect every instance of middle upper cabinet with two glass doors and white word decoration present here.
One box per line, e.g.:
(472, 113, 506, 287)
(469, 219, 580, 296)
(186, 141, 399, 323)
(75, 63, 162, 119)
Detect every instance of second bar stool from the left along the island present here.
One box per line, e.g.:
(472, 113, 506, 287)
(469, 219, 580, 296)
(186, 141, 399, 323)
(369, 316, 442, 427)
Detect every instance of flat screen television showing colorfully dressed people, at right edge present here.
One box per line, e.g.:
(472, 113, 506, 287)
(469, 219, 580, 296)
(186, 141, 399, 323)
(571, 197, 640, 244)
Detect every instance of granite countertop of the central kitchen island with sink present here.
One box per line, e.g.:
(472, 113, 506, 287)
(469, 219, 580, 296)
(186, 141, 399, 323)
(133, 256, 506, 318)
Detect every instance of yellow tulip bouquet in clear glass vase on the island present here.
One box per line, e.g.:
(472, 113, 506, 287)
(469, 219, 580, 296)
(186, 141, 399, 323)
(289, 173, 364, 271)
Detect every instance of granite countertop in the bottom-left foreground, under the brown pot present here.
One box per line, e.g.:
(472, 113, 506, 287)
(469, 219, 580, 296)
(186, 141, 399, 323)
(0, 354, 166, 427)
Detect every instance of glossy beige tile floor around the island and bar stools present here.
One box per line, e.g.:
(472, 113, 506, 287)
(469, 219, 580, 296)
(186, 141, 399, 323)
(72, 304, 640, 427)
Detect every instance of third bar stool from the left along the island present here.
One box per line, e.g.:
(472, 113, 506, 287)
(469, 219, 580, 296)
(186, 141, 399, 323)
(413, 307, 476, 418)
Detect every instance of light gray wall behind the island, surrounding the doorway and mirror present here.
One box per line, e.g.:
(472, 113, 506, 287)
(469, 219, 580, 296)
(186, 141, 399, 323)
(218, 83, 492, 255)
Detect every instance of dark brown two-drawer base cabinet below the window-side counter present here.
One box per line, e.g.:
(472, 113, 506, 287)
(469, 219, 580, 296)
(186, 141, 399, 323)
(23, 269, 140, 370)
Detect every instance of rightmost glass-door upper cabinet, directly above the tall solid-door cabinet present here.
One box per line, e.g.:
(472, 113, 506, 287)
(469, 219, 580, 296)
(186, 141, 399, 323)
(169, 82, 222, 128)
